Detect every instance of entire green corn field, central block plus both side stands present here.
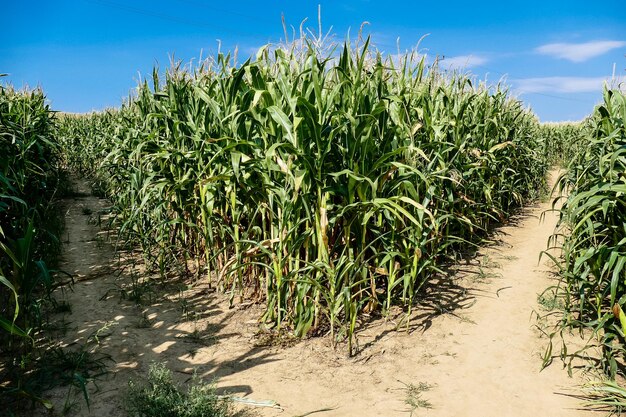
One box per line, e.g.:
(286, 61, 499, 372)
(6, 31, 626, 412)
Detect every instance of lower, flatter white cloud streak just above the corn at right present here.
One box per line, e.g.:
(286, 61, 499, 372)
(512, 77, 610, 94)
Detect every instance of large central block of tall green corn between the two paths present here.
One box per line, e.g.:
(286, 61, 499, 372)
(60, 42, 548, 350)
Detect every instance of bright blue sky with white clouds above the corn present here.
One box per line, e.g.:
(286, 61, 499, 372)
(0, 0, 626, 121)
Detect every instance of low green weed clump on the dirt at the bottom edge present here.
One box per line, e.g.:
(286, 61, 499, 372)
(126, 364, 234, 417)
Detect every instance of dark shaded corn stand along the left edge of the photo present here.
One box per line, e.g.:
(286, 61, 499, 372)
(0, 80, 78, 412)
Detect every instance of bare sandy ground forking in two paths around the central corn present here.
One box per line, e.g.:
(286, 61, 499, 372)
(39, 175, 589, 417)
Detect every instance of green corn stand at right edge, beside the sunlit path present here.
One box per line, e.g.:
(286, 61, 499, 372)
(553, 89, 626, 377)
